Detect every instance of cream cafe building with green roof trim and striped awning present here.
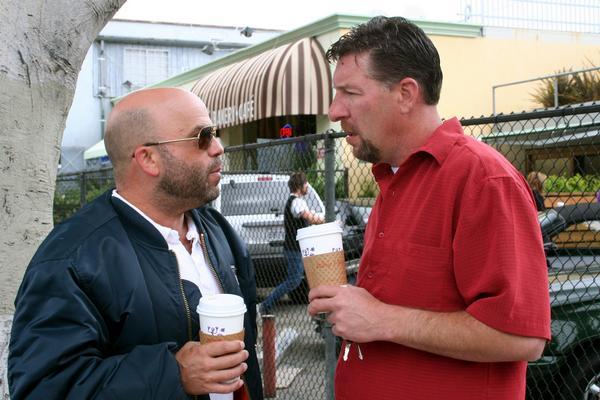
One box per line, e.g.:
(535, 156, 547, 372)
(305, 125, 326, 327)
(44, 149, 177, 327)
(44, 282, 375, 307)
(145, 15, 600, 145)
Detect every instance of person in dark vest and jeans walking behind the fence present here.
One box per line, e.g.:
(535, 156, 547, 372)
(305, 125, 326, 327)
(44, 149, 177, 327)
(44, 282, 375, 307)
(259, 172, 325, 314)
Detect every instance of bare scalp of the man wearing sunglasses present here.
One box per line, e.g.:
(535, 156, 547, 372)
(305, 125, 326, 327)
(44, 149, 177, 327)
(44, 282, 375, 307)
(104, 88, 208, 179)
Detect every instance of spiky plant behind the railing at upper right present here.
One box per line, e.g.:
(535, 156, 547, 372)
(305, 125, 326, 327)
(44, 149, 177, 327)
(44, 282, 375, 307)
(531, 64, 600, 107)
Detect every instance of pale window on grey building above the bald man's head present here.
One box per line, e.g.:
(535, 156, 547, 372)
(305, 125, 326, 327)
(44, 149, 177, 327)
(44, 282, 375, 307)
(123, 47, 169, 91)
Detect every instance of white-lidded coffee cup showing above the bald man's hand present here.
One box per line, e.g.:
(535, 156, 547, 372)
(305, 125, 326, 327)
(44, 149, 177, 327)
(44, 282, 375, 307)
(196, 294, 246, 342)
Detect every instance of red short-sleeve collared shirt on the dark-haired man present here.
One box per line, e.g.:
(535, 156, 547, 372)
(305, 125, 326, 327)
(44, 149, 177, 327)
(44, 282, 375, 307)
(335, 119, 550, 400)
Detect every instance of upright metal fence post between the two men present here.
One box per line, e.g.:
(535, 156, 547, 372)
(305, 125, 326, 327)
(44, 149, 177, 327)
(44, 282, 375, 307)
(323, 130, 337, 400)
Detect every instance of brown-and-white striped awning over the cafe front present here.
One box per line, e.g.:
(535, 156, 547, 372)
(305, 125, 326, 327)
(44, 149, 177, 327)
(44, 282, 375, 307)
(192, 38, 332, 128)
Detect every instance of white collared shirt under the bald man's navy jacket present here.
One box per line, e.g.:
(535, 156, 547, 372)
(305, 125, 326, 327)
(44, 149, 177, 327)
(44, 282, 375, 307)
(112, 190, 233, 400)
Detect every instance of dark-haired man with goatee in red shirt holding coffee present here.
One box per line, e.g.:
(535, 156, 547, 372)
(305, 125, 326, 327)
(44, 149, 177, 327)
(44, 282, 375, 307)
(308, 17, 550, 400)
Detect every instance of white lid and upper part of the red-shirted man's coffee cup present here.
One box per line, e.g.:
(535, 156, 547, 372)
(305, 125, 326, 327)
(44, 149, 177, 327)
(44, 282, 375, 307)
(296, 222, 344, 257)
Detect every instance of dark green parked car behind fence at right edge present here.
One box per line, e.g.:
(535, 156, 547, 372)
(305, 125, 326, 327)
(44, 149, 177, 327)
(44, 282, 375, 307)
(527, 203, 600, 400)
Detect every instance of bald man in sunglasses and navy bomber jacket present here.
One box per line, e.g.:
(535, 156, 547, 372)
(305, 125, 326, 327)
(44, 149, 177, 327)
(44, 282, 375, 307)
(8, 88, 263, 400)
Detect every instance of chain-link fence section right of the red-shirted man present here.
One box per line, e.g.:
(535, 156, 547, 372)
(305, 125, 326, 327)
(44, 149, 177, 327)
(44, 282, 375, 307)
(461, 104, 600, 400)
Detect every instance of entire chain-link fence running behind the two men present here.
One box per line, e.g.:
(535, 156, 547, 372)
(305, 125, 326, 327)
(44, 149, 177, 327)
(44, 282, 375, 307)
(55, 105, 600, 399)
